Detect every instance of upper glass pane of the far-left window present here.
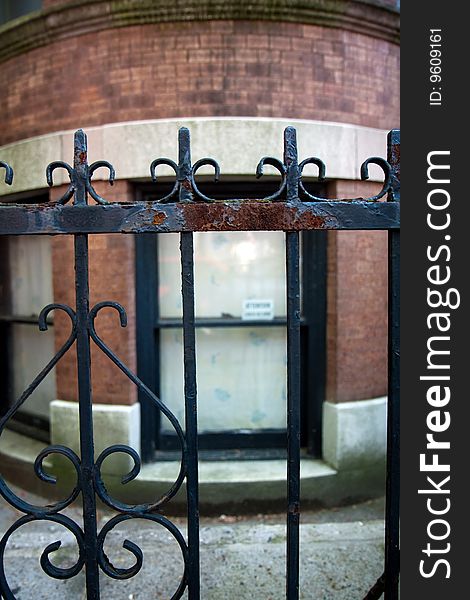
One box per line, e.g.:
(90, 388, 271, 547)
(9, 235, 53, 316)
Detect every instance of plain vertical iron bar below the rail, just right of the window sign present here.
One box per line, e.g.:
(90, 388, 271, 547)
(286, 231, 300, 600)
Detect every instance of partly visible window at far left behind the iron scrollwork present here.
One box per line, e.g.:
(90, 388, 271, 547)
(0, 236, 56, 441)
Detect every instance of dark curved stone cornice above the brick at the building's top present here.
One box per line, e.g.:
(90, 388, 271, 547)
(0, 0, 399, 61)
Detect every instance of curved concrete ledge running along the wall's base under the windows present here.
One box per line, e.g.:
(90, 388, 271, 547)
(0, 430, 385, 514)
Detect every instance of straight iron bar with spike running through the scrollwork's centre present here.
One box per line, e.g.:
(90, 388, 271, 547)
(73, 129, 100, 600)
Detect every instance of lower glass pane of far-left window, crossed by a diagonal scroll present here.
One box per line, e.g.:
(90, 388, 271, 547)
(11, 323, 56, 418)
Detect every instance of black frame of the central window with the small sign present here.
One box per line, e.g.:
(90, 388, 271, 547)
(135, 180, 327, 462)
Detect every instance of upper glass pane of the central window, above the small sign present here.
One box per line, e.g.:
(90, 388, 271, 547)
(158, 231, 286, 318)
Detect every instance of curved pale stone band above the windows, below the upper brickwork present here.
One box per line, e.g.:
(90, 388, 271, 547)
(0, 117, 387, 196)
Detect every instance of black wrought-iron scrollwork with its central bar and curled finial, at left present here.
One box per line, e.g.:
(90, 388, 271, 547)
(0, 130, 191, 600)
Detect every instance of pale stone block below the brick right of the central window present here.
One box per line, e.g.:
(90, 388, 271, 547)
(323, 397, 387, 470)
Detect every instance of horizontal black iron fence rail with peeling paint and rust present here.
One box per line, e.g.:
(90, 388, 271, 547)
(0, 200, 400, 235)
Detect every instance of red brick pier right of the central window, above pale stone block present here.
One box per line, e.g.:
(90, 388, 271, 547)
(326, 181, 388, 402)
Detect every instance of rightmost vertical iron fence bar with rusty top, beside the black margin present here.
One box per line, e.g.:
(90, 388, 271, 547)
(385, 130, 400, 600)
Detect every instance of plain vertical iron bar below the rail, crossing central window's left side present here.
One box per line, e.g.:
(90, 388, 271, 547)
(180, 233, 200, 600)
